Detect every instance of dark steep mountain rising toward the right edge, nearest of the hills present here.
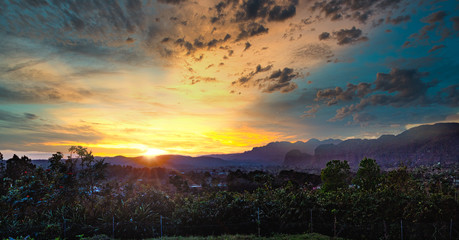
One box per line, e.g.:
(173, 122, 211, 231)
(284, 123, 459, 169)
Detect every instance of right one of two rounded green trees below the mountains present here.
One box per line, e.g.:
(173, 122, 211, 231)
(353, 158, 381, 191)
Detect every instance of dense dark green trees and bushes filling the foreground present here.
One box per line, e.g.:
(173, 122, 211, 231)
(0, 147, 459, 239)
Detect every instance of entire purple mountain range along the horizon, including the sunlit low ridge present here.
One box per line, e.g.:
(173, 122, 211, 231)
(30, 123, 459, 169)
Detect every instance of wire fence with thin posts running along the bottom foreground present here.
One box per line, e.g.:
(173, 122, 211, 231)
(9, 209, 459, 240)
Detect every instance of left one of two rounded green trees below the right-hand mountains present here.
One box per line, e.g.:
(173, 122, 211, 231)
(320, 160, 350, 191)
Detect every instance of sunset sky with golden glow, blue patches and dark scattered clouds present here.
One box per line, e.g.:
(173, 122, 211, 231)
(0, 0, 459, 158)
